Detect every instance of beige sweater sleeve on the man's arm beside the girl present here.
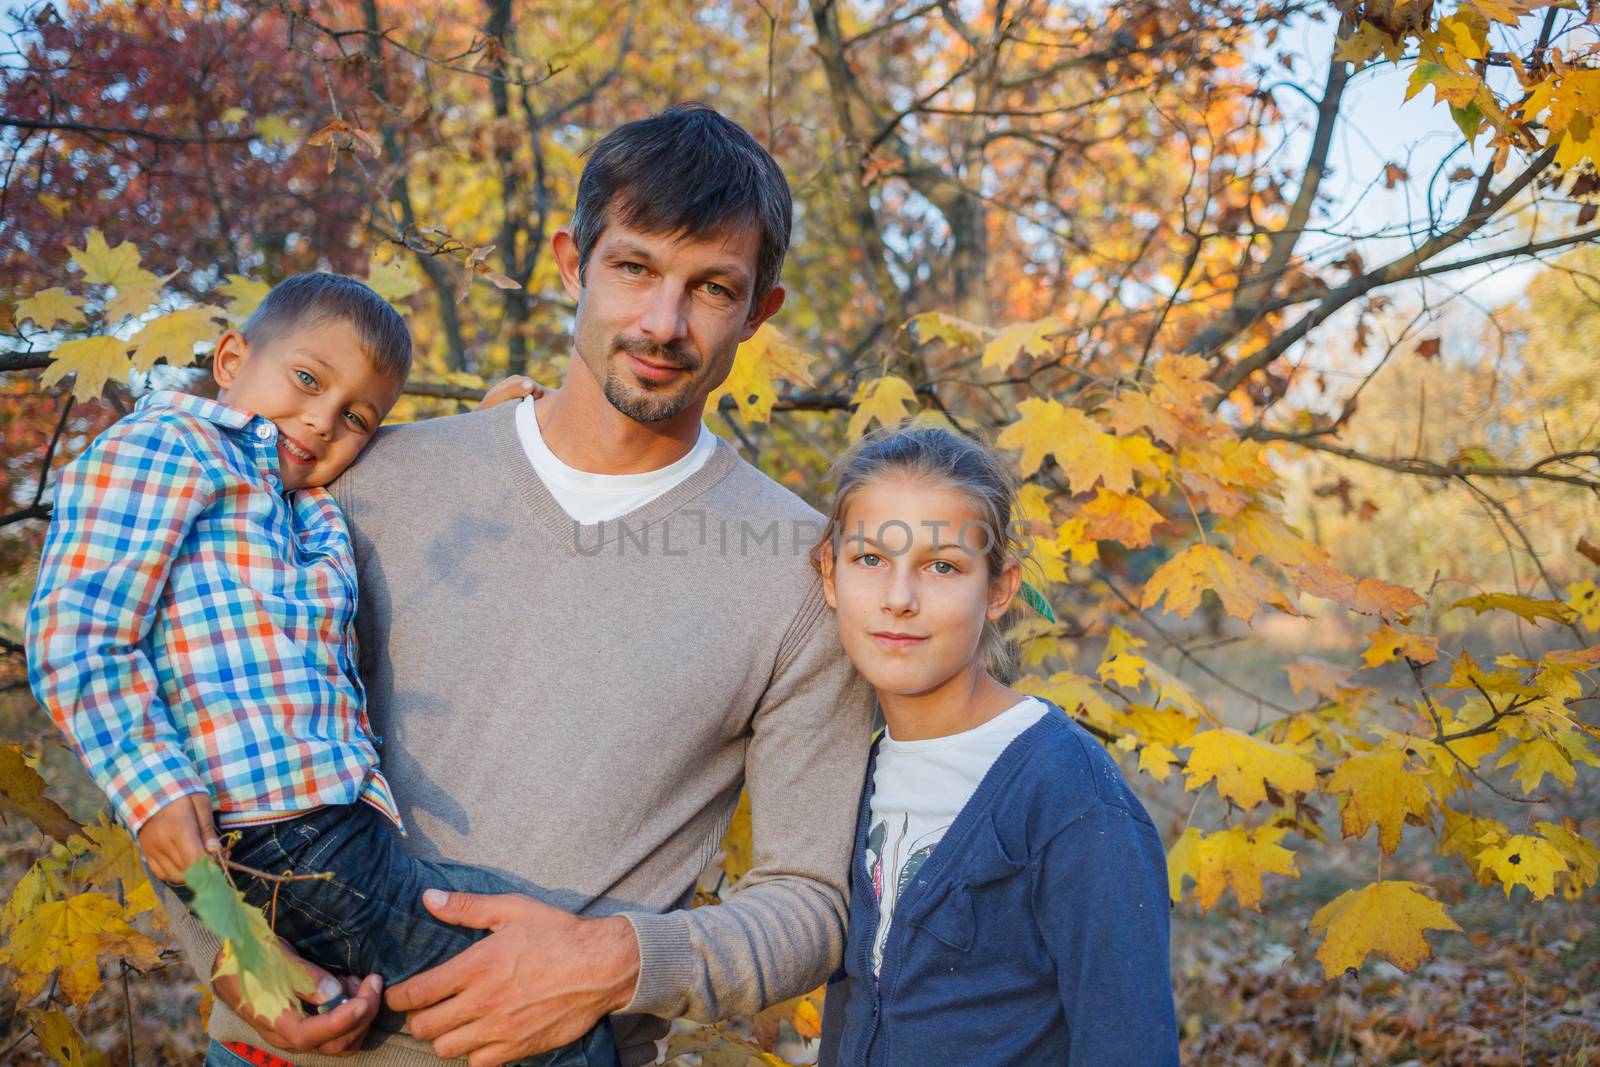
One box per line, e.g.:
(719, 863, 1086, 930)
(622, 582, 872, 1021)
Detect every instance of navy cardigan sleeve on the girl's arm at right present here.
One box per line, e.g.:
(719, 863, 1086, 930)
(1034, 803, 1178, 1067)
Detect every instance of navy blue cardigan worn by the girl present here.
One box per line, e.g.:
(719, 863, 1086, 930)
(818, 705, 1178, 1067)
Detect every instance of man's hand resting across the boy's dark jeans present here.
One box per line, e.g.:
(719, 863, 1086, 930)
(387, 889, 638, 1067)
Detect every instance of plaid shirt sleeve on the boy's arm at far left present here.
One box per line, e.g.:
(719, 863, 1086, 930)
(26, 421, 216, 833)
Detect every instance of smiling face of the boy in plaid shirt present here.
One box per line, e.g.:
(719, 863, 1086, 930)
(211, 310, 405, 490)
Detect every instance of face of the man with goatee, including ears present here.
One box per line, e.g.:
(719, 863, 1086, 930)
(557, 222, 782, 422)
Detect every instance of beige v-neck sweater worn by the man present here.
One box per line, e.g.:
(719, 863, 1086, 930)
(165, 405, 870, 1067)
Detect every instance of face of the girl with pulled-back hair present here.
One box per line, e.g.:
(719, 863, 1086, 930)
(822, 475, 1021, 696)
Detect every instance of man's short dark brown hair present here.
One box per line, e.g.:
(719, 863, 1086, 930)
(571, 104, 794, 314)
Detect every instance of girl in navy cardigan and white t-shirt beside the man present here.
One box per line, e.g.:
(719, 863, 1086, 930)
(813, 427, 1178, 1067)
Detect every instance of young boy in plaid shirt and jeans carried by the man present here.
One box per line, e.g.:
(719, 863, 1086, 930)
(27, 274, 616, 1067)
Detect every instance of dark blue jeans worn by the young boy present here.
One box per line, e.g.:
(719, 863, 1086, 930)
(173, 803, 618, 1067)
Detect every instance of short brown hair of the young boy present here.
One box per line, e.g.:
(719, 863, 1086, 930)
(238, 270, 411, 381)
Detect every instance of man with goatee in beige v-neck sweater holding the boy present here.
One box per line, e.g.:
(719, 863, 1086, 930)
(174, 106, 870, 1067)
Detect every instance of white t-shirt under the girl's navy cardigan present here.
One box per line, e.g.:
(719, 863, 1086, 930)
(866, 697, 1050, 973)
